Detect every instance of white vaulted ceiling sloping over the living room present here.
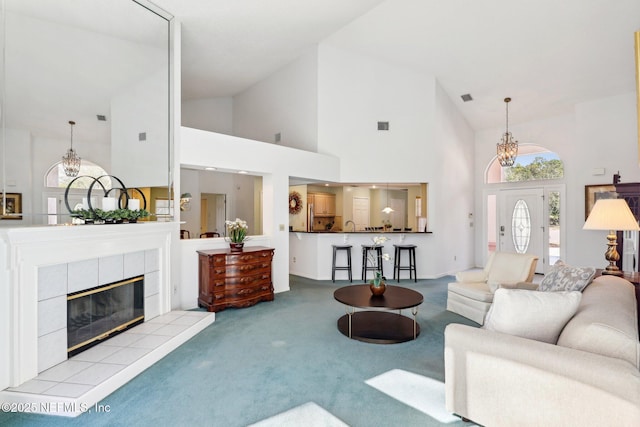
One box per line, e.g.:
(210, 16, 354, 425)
(159, 0, 640, 130)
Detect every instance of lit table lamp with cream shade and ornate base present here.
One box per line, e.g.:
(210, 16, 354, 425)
(582, 199, 640, 276)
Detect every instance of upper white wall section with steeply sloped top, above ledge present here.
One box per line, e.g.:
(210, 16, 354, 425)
(233, 49, 318, 151)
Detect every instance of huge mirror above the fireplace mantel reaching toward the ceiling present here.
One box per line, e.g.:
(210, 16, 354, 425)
(0, 0, 172, 226)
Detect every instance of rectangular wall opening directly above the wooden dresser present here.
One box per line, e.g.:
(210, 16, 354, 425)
(180, 167, 262, 238)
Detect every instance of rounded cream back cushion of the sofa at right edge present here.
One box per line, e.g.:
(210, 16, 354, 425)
(556, 276, 640, 368)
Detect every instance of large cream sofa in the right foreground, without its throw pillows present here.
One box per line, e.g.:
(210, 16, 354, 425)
(444, 276, 640, 427)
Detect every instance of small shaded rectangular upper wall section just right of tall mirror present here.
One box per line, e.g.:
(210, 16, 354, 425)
(182, 97, 233, 135)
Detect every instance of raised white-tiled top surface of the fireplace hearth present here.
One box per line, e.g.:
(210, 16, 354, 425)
(6, 311, 212, 398)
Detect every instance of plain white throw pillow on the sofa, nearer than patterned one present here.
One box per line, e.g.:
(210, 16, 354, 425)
(483, 288, 582, 344)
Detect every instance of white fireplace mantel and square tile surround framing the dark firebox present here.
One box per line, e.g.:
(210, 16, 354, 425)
(0, 222, 213, 416)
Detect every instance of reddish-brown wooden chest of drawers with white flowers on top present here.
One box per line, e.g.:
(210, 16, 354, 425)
(198, 246, 274, 311)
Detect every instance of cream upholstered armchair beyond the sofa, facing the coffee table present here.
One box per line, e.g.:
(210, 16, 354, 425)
(447, 252, 538, 325)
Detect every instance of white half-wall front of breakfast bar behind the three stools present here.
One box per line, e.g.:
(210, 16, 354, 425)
(289, 231, 438, 283)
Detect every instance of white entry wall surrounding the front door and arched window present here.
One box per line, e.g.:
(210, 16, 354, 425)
(474, 93, 640, 267)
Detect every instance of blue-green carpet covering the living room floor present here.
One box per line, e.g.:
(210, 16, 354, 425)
(0, 276, 475, 427)
